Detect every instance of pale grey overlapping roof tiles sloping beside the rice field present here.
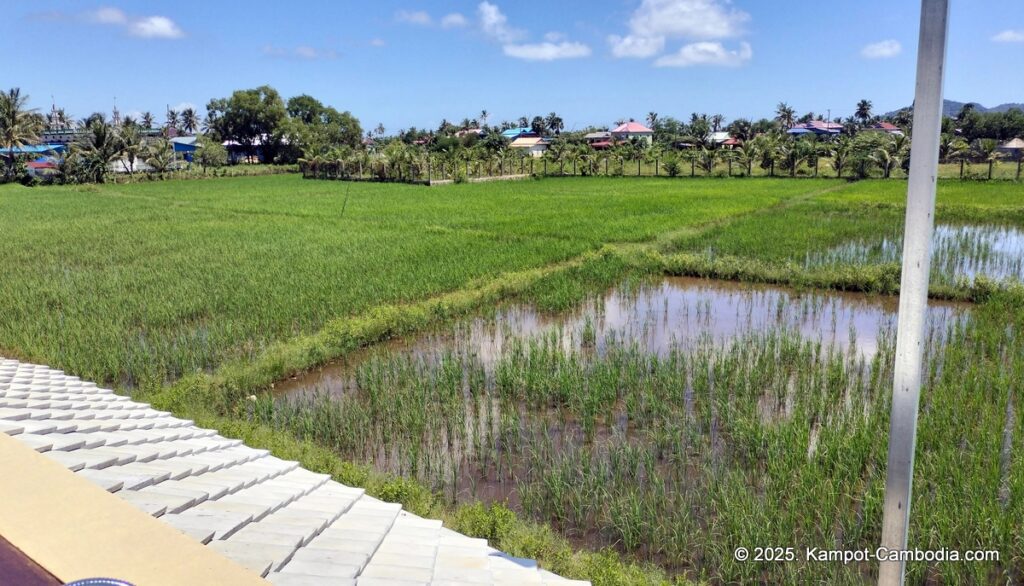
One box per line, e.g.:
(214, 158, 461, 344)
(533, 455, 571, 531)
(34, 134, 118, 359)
(0, 359, 583, 586)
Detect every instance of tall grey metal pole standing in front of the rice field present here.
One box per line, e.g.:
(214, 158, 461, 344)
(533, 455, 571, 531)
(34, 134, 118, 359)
(879, 0, 949, 586)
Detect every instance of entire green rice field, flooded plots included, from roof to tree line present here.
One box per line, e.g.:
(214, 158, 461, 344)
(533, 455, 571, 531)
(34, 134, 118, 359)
(0, 175, 1024, 585)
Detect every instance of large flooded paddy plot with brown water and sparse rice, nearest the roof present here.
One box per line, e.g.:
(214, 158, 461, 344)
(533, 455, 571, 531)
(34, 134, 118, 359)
(253, 279, 1022, 582)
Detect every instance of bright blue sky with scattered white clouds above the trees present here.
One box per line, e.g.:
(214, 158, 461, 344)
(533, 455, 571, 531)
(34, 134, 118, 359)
(0, 0, 1024, 130)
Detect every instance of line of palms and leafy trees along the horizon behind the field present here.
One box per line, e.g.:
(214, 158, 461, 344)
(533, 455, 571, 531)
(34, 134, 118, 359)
(0, 85, 1024, 182)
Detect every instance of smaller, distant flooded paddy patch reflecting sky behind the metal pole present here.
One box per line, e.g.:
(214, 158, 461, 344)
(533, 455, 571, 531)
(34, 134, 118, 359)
(804, 224, 1024, 284)
